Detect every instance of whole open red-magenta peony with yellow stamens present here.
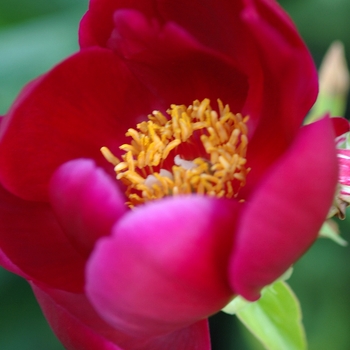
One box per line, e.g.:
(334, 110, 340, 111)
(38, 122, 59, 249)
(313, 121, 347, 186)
(0, 0, 337, 350)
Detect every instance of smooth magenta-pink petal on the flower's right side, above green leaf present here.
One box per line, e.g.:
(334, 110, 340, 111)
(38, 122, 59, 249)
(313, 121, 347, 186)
(230, 118, 338, 301)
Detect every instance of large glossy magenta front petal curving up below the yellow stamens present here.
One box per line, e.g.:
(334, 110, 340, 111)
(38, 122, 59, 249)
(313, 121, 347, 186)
(86, 196, 238, 337)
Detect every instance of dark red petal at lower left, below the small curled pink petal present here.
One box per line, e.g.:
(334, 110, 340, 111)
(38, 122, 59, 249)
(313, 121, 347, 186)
(0, 182, 85, 291)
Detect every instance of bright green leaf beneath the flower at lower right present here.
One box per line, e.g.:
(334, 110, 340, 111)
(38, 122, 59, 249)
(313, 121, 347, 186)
(236, 281, 307, 350)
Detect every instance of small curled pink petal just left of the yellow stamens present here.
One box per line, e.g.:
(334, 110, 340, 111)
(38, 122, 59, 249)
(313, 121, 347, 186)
(50, 159, 126, 255)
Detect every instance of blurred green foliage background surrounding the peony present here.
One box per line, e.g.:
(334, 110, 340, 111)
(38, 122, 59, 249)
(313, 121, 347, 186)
(0, 0, 350, 350)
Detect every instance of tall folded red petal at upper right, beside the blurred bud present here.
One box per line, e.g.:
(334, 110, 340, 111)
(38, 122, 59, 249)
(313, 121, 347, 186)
(242, 0, 318, 191)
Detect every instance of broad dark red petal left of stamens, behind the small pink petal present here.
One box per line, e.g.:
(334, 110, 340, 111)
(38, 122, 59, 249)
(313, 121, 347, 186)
(0, 48, 159, 201)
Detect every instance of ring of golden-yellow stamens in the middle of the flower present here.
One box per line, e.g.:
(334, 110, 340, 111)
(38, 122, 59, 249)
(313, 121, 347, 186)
(101, 99, 250, 207)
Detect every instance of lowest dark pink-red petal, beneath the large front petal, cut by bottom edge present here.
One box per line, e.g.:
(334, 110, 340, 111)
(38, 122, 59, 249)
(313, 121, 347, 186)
(31, 283, 210, 350)
